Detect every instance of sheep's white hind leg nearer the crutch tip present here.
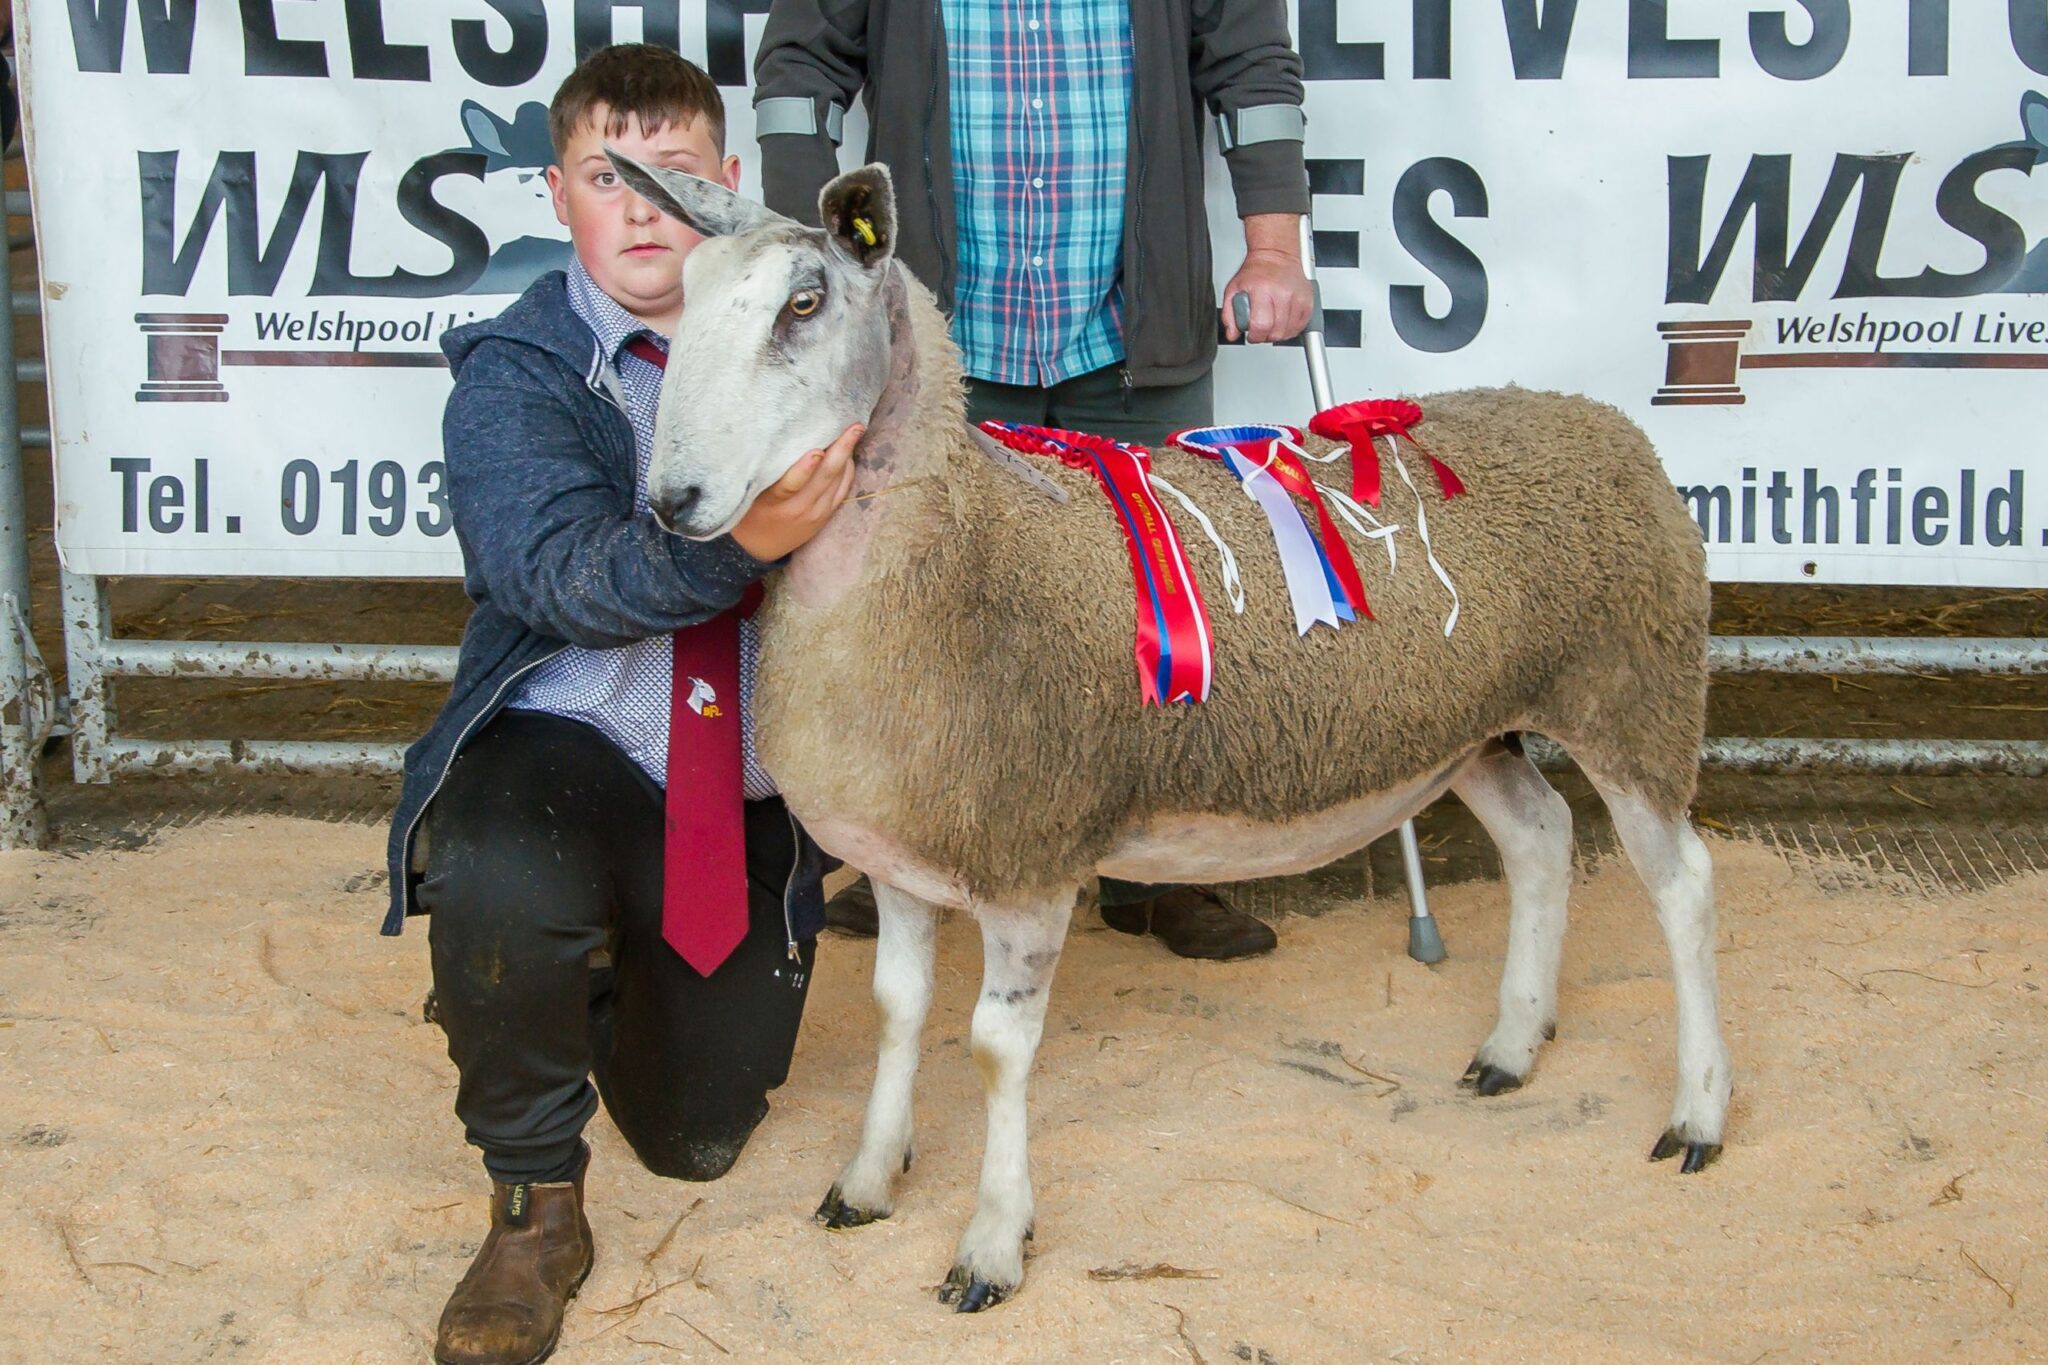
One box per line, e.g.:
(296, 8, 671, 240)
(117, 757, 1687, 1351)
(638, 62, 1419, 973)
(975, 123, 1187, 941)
(1450, 745, 1571, 1095)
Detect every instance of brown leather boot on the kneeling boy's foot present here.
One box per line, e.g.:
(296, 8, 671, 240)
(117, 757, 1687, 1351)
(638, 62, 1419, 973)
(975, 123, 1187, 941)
(434, 1148, 596, 1365)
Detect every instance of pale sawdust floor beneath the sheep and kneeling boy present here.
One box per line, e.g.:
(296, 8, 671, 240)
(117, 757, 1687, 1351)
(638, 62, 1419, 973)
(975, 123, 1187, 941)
(0, 819, 2048, 1365)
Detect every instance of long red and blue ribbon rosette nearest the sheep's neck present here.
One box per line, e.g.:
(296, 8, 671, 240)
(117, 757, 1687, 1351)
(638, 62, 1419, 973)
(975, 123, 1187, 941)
(981, 422, 1214, 706)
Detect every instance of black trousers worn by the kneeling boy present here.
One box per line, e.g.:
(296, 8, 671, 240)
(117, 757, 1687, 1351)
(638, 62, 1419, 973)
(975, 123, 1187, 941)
(418, 710, 815, 1183)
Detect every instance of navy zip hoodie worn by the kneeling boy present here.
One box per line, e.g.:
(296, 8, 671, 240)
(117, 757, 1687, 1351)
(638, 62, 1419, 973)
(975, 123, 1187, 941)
(383, 270, 825, 945)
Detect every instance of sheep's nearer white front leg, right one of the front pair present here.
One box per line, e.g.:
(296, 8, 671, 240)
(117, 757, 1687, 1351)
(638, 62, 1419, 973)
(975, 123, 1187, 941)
(938, 890, 1075, 1314)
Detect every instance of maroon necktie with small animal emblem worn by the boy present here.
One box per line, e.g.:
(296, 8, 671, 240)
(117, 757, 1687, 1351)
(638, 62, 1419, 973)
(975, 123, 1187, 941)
(627, 336, 762, 976)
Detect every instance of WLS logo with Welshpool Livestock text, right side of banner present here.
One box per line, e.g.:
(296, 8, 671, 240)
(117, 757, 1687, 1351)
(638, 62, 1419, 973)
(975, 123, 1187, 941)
(1651, 90, 2048, 407)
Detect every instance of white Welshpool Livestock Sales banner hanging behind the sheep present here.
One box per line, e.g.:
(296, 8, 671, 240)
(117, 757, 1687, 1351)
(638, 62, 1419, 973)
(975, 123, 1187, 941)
(16, 0, 2048, 587)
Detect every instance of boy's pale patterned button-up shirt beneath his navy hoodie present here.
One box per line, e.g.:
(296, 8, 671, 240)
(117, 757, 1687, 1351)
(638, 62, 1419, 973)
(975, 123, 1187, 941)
(506, 258, 776, 800)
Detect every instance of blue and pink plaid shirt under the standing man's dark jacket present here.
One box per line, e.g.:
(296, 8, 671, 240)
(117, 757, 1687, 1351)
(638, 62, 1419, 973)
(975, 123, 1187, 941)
(940, 0, 1130, 387)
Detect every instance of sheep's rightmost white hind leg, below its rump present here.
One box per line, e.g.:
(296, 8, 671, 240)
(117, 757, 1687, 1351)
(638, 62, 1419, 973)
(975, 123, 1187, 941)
(1587, 774, 1735, 1175)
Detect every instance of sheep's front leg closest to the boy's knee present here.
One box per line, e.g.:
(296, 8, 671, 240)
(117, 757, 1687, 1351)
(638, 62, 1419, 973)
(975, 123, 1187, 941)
(817, 882, 938, 1228)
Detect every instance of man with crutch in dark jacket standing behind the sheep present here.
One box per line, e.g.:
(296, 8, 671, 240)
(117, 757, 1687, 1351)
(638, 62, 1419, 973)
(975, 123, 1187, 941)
(754, 0, 1311, 958)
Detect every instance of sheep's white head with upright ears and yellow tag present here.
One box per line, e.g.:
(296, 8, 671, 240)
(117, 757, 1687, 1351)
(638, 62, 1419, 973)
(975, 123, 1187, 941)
(606, 149, 895, 540)
